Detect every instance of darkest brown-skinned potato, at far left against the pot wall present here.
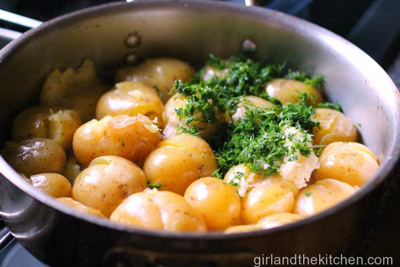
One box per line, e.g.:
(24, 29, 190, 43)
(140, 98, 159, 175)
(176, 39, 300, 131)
(2, 138, 66, 177)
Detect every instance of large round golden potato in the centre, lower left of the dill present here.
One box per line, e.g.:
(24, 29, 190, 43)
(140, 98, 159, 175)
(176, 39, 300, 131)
(143, 134, 217, 195)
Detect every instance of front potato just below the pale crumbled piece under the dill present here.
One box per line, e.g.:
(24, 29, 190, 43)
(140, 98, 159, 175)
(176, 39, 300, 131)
(242, 178, 297, 224)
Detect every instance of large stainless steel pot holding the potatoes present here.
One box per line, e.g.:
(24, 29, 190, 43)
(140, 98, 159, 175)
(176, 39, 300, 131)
(0, 0, 400, 266)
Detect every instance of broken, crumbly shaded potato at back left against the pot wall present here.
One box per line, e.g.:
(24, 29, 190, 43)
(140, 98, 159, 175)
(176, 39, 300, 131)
(40, 60, 106, 122)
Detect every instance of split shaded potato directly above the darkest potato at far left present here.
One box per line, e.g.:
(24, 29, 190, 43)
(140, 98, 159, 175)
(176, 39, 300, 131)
(11, 107, 82, 149)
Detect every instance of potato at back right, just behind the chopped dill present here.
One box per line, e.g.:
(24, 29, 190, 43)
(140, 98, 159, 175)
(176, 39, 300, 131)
(265, 79, 323, 104)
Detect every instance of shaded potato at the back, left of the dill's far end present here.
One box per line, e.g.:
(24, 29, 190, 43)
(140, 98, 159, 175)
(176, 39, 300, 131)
(115, 58, 194, 102)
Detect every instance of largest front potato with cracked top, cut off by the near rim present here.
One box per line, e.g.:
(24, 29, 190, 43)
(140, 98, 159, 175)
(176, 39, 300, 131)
(110, 189, 207, 232)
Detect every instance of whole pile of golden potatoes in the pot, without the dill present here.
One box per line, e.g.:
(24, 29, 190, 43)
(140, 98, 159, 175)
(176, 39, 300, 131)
(2, 58, 379, 233)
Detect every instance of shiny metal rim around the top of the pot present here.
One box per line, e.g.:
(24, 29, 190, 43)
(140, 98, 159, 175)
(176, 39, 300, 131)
(0, 0, 400, 241)
